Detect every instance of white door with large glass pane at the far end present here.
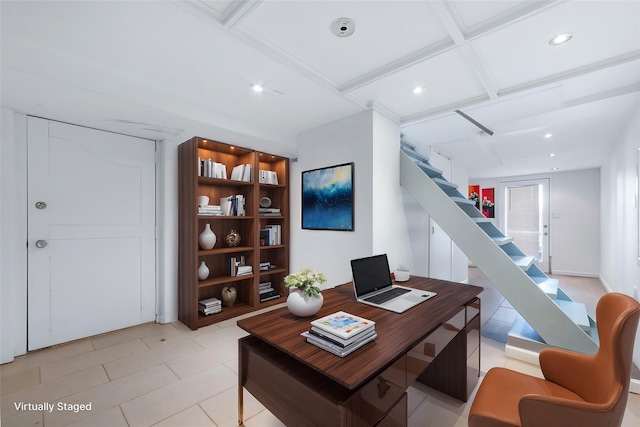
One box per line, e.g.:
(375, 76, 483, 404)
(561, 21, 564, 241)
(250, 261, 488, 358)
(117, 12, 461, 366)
(500, 178, 550, 273)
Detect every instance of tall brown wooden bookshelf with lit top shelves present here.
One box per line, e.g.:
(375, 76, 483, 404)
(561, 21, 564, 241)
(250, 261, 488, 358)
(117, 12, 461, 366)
(178, 137, 289, 330)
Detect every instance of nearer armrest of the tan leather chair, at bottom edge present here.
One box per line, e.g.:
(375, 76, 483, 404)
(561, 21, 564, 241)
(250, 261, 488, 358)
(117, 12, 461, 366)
(518, 394, 612, 427)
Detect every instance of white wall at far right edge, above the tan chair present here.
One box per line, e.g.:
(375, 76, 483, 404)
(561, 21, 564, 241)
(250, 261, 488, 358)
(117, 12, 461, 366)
(600, 108, 640, 366)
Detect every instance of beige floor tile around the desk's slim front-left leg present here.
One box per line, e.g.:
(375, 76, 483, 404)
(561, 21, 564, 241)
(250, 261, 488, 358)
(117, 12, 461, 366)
(200, 387, 265, 427)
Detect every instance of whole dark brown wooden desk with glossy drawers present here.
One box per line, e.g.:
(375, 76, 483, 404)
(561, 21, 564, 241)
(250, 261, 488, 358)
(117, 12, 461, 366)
(238, 277, 482, 427)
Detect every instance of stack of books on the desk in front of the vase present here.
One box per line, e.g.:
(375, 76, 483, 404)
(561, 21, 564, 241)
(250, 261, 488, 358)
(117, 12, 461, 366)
(302, 311, 377, 357)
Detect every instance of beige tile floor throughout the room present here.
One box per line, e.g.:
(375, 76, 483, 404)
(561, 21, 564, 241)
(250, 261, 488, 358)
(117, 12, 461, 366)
(0, 268, 640, 427)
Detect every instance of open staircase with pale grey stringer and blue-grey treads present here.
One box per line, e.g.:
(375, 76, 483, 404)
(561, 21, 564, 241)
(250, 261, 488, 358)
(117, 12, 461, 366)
(400, 141, 598, 363)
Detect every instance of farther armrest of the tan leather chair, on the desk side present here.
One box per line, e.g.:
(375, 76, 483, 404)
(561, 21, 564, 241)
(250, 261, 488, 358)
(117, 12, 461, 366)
(540, 348, 594, 398)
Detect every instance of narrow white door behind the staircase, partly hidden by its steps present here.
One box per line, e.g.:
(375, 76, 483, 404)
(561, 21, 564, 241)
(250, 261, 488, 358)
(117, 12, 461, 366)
(429, 150, 453, 280)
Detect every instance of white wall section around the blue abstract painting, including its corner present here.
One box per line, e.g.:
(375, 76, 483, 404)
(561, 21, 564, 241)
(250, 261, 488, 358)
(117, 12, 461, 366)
(290, 111, 410, 287)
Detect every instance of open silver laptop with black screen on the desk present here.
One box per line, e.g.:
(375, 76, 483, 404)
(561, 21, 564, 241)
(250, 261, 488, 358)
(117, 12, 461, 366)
(351, 254, 436, 313)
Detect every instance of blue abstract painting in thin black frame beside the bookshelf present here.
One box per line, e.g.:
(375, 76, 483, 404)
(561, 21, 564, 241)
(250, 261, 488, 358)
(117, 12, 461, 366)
(302, 163, 354, 231)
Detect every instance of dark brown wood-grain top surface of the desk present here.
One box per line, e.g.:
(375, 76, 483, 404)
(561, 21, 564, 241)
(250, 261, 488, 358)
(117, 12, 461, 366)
(238, 276, 483, 389)
